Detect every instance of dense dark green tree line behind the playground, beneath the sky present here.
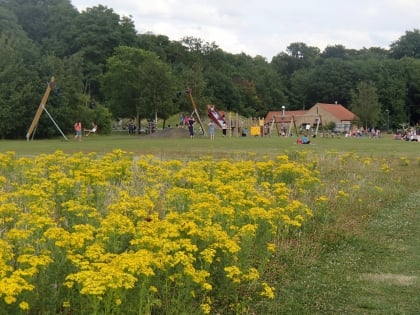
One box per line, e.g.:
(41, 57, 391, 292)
(0, 0, 420, 139)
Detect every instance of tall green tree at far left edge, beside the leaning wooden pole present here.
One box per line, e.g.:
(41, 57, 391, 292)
(0, 6, 42, 138)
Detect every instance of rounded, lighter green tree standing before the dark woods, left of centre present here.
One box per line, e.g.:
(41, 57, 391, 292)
(101, 46, 176, 127)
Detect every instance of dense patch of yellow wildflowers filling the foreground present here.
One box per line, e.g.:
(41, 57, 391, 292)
(0, 150, 316, 314)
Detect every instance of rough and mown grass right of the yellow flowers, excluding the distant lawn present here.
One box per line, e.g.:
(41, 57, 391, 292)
(265, 154, 420, 315)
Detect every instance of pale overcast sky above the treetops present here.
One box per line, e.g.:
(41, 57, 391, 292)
(71, 0, 420, 61)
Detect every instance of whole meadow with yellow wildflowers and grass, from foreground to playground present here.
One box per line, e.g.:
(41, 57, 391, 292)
(0, 134, 420, 315)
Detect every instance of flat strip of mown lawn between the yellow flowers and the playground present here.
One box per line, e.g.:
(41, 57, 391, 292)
(0, 133, 420, 158)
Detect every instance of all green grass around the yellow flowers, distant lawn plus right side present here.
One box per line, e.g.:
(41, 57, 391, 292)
(0, 134, 420, 315)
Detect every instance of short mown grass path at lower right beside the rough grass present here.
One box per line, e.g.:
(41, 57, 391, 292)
(278, 191, 420, 315)
